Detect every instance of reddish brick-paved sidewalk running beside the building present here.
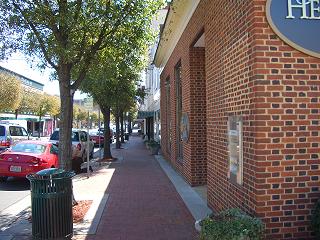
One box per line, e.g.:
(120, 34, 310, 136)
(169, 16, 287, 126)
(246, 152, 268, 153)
(80, 137, 198, 240)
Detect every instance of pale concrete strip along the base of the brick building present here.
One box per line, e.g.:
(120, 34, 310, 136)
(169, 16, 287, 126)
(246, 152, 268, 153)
(155, 155, 212, 220)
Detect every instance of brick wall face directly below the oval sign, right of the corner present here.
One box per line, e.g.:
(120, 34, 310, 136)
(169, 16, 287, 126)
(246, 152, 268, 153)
(253, 1, 320, 239)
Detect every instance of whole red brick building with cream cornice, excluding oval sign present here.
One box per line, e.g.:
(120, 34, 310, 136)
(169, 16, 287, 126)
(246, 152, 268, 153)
(155, 0, 320, 239)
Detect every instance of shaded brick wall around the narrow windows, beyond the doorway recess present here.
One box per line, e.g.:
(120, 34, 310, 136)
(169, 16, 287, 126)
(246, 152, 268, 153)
(161, 1, 207, 186)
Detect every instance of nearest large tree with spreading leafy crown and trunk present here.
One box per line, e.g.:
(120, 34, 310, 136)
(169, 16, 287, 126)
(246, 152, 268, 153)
(0, 0, 162, 169)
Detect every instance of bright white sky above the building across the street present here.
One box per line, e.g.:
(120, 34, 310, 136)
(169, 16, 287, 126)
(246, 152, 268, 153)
(0, 53, 86, 99)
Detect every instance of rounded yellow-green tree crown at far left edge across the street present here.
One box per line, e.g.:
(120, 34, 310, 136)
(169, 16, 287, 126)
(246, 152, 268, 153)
(0, 73, 22, 111)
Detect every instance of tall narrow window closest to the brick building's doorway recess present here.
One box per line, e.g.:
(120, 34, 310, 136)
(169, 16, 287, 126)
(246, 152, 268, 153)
(175, 61, 183, 162)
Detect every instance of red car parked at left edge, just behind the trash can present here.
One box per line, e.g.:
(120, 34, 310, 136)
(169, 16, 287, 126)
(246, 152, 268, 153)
(0, 141, 59, 181)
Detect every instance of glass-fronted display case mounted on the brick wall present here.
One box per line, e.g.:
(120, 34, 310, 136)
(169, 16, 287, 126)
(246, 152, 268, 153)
(228, 116, 243, 184)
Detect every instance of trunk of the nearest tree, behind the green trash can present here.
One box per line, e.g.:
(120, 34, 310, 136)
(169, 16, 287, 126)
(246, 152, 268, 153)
(58, 67, 74, 170)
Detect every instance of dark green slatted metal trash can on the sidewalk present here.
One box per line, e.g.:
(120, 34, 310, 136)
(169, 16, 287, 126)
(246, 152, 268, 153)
(27, 168, 75, 239)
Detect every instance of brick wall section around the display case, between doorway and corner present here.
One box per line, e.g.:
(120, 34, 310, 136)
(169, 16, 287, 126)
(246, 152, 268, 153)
(202, 1, 258, 221)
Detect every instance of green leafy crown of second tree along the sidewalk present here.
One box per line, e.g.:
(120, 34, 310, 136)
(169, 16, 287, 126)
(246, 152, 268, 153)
(80, 1, 161, 114)
